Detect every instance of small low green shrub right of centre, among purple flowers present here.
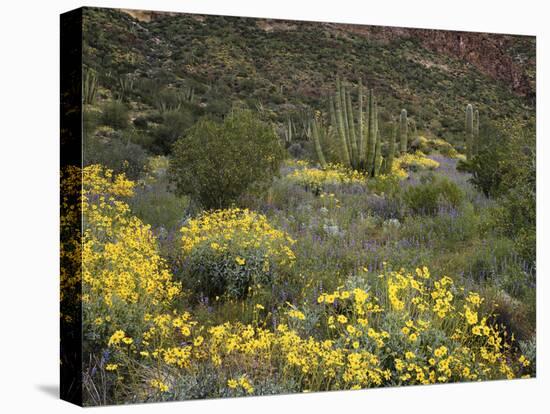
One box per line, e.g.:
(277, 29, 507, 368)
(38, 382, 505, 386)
(403, 175, 464, 215)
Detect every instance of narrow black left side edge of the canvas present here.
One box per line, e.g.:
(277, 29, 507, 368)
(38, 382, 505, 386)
(59, 8, 83, 406)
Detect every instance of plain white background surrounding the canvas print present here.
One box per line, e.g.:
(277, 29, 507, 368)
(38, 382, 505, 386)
(0, 0, 550, 414)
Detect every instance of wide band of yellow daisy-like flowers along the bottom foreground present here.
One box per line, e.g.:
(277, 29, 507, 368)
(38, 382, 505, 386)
(102, 267, 530, 394)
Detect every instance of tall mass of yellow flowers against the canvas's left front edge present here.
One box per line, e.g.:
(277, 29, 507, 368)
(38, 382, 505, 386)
(75, 165, 181, 342)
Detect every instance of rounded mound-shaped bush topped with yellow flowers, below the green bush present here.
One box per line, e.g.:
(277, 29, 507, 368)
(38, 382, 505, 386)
(181, 209, 295, 298)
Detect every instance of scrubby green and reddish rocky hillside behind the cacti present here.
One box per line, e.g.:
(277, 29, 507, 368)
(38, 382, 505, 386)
(84, 8, 535, 146)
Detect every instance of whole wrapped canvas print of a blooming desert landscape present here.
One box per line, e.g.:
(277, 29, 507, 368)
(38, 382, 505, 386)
(61, 7, 536, 406)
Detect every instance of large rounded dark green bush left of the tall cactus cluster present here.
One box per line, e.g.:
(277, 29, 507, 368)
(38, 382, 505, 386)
(170, 111, 284, 209)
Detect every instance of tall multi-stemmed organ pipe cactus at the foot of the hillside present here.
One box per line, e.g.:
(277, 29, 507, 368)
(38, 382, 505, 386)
(312, 78, 406, 176)
